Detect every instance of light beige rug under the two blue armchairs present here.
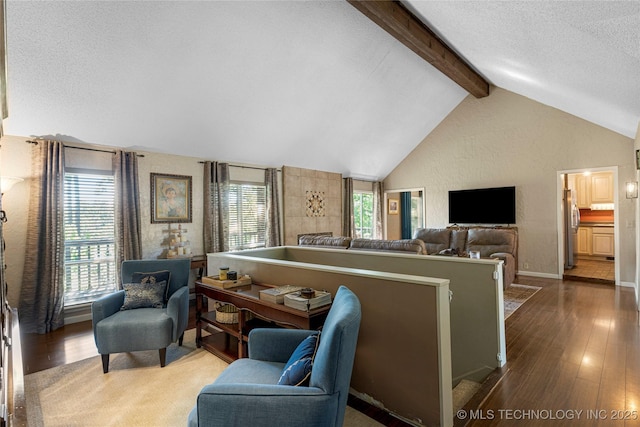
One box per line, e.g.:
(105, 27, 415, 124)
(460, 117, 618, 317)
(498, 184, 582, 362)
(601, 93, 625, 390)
(25, 330, 381, 427)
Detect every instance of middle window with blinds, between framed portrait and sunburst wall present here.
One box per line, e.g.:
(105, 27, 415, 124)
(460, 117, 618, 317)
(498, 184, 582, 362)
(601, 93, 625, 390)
(229, 183, 267, 251)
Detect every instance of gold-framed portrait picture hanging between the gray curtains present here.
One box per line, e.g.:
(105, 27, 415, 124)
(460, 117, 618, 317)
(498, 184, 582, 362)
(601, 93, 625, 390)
(151, 173, 191, 224)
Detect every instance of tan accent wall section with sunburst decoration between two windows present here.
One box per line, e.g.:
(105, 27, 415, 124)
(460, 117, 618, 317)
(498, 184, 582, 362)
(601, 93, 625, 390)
(282, 166, 342, 245)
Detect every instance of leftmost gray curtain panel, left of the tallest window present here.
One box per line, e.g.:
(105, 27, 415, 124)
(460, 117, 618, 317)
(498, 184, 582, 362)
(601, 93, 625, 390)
(18, 141, 64, 334)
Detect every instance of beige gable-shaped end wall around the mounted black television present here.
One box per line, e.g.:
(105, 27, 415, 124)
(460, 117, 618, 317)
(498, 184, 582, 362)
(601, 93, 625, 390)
(384, 88, 636, 283)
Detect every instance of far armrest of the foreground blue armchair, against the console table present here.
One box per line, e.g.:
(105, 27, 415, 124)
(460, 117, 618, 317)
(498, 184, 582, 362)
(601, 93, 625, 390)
(249, 328, 318, 363)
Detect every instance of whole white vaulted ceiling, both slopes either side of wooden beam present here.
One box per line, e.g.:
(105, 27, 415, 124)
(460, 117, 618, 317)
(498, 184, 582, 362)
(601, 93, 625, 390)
(4, 0, 640, 179)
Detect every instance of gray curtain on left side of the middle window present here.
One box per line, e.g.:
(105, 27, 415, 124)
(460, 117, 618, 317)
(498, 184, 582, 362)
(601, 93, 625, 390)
(203, 162, 229, 253)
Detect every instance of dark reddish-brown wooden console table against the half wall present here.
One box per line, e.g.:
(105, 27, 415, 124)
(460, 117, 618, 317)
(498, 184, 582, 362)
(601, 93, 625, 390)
(195, 281, 331, 363)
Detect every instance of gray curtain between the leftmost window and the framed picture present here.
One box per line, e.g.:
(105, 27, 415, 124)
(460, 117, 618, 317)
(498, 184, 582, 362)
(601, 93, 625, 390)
(113, 150, 142, 270)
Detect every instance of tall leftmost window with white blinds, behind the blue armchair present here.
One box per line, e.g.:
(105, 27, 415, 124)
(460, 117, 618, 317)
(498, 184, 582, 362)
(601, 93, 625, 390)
(64, 171, 117, 306)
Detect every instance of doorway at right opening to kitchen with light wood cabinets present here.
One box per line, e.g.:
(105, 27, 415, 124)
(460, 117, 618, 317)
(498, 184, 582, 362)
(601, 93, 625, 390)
(558, 168, 619, 285)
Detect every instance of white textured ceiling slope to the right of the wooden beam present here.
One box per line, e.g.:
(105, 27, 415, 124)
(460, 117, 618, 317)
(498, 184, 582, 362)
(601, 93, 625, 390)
(404, 0, 640, 138)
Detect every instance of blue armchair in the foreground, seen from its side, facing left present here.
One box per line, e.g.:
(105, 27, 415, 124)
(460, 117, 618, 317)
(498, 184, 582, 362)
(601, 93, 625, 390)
(188, 286, 361, 427)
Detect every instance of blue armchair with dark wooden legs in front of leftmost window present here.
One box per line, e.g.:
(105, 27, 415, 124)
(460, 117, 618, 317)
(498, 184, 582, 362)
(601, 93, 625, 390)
(91, 258, 191, 374)
